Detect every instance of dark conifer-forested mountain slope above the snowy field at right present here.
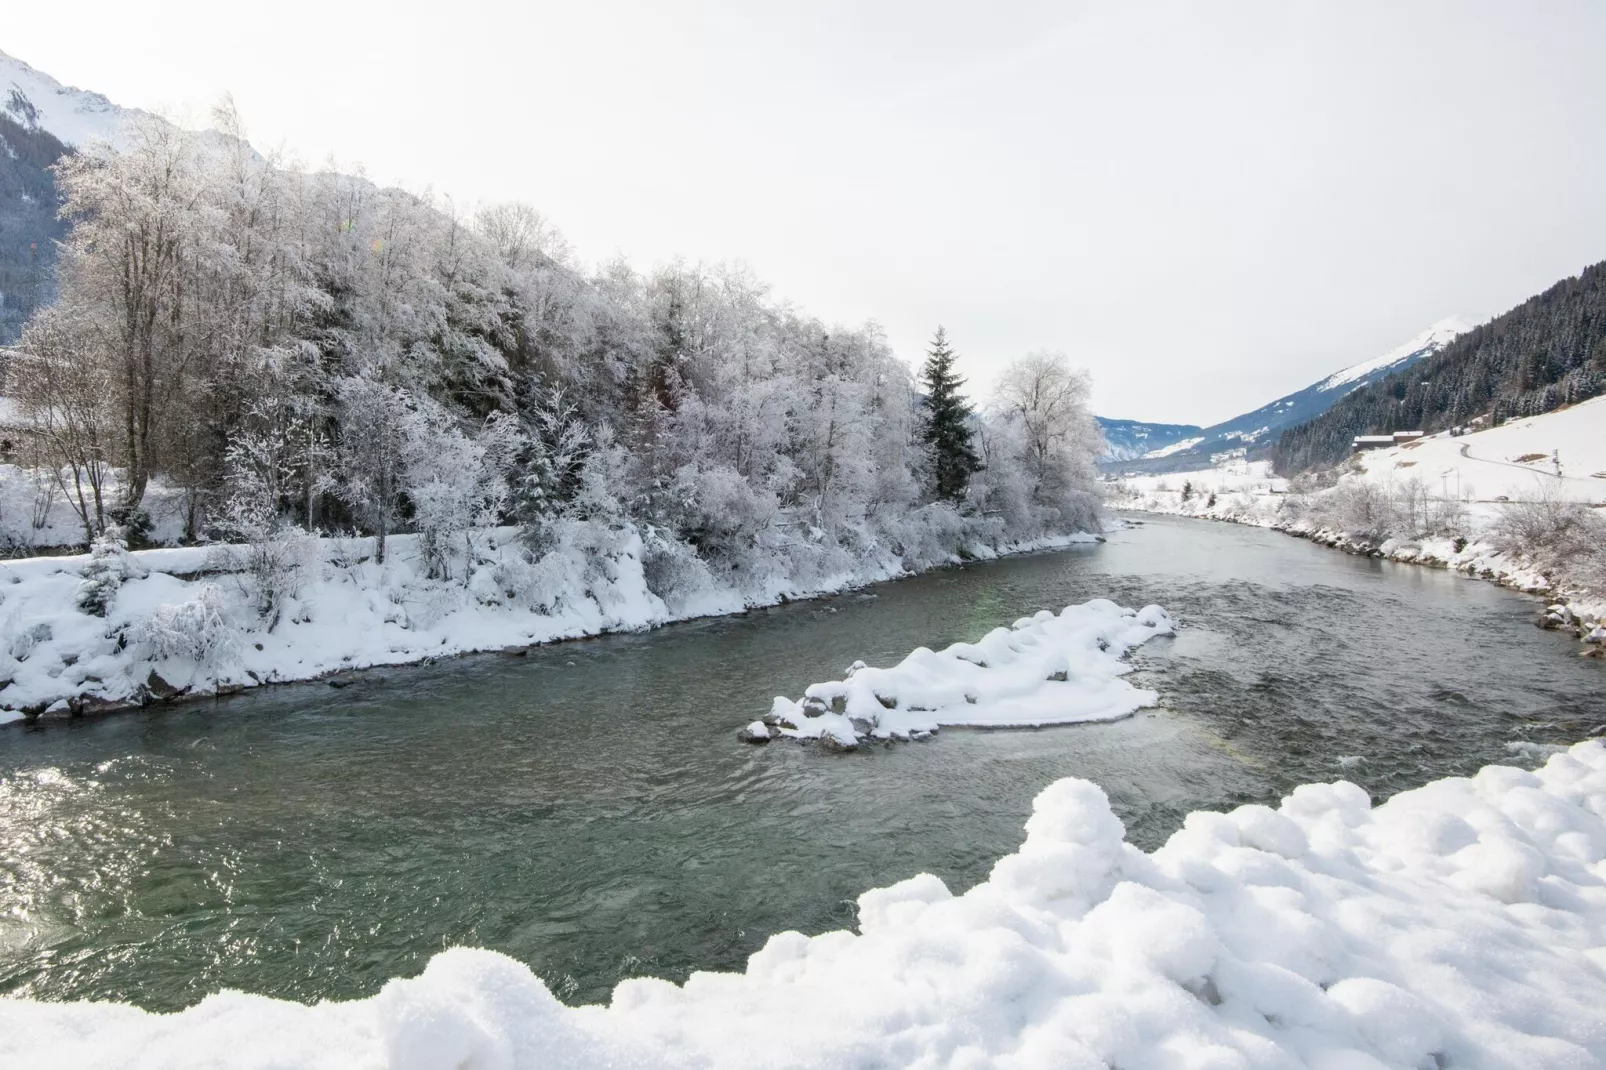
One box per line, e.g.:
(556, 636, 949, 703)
(1274, 262, 1606, 474)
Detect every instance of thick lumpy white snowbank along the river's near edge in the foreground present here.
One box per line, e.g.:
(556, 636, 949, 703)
(9, 741, 1606, 1070)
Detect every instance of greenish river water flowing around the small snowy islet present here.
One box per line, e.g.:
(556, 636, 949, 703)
(0, 517, 1606, 1011)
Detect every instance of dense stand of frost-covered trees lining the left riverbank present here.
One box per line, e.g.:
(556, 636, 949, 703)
(14, 104, 1117, 588)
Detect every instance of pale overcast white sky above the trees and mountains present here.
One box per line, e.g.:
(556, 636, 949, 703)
(0, 0, 1606, 424)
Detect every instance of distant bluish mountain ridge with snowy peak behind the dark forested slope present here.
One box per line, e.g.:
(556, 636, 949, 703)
(1103, 317, 1468, 472)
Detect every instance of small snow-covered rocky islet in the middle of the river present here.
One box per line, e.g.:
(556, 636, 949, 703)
(742, 598, 1176, 747)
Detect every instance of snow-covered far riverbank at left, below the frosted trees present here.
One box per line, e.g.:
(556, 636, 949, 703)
(0, 524, 1097, 725)
